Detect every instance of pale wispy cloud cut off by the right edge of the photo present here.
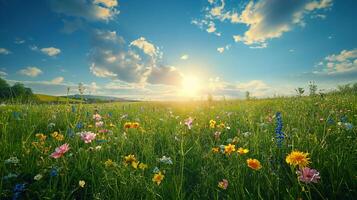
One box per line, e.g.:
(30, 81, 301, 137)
(314, 49, 357, 75)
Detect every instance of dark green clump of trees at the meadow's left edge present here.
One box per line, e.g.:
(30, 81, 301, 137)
(0, 78, 37, 103)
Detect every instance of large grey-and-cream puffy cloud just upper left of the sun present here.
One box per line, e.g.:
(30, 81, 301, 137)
(89, 30, 182, 85)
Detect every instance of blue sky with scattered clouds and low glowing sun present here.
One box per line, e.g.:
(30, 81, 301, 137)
(0, 0, 357, 100)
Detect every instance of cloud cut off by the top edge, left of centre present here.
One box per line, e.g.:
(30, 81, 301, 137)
(51, 0, 119, 21)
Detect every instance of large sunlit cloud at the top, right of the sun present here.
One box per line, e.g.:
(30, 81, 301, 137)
(191, 0, 332, 48)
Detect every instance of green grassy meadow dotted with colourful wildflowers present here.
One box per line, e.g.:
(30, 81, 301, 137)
(0, 95, 357, 199)
